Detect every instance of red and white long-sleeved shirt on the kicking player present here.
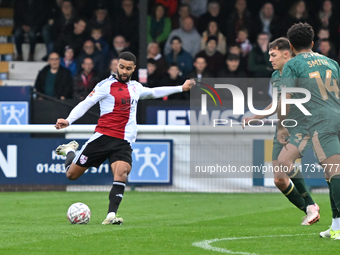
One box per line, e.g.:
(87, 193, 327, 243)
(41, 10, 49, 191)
(66, 76, 183, 143)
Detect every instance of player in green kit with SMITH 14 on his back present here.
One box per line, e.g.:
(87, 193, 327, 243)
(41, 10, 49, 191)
(277, 23, 340, 240)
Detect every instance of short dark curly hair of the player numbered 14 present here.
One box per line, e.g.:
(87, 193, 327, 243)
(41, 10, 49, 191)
(287, 22, 314, 50)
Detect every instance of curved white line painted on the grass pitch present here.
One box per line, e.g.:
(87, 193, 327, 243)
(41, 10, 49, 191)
(192, 234, 314, 255)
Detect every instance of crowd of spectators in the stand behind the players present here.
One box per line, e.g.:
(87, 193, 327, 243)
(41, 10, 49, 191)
(7, 0, 340, 99)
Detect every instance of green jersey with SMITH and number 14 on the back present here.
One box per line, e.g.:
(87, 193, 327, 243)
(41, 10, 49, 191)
(282, 51, 340, 133)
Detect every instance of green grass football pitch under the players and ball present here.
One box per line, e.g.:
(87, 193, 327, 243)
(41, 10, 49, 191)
(0, 192, 340, 255)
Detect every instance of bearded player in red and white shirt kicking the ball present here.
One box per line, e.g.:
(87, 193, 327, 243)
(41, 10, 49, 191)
(55, 52, 195, 224)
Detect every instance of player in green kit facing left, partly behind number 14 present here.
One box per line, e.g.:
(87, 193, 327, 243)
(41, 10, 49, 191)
(244, 37, 320, 225)
